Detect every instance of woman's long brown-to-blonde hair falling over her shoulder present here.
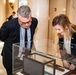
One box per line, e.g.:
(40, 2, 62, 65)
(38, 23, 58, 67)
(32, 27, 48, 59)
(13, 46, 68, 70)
(52, 14, 76, 38)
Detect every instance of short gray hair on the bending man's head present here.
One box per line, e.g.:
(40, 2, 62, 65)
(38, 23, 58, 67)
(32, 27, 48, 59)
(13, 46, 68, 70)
(17, 5, 31, 18)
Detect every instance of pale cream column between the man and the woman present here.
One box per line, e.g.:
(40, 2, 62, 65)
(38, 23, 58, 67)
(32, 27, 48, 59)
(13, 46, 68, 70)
(28, 0, 49, 52)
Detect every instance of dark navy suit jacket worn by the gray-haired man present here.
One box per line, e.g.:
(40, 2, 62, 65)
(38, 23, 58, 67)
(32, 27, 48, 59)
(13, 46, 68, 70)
(0, 18, 38, 68)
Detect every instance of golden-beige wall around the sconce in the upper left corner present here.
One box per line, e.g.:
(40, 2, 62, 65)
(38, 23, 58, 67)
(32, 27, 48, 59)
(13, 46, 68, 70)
(0, 0, 18, 27)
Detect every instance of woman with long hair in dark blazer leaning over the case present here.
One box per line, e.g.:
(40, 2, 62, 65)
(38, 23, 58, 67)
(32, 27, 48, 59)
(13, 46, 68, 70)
(52, 14, 76, 70)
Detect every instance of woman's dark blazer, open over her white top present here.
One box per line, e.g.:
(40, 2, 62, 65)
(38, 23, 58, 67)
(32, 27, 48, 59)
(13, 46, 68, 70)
(59, 33, 76, 56)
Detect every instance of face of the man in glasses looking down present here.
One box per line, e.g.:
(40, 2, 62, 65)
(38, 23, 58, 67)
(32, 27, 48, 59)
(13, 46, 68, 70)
(18, 15, 32, 29)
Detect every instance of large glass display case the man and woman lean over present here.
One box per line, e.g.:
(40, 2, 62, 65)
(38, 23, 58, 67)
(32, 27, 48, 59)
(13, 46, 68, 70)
(12, 40, 76, 75)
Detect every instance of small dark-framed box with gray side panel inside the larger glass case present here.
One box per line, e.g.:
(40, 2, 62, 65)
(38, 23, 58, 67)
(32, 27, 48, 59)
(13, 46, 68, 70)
(23, 53, 55, 75)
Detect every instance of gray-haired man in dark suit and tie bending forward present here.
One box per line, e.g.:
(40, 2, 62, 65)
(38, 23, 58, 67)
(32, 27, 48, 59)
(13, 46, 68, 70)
(0, 5, 38, 75)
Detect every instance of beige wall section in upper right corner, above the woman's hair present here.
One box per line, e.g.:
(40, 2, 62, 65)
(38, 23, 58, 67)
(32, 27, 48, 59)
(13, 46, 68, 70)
(66, 0, 76, 24)
